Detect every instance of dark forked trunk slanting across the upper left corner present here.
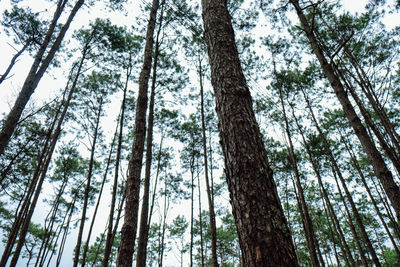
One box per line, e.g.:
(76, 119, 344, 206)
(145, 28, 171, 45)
(0, 0, 84, 155)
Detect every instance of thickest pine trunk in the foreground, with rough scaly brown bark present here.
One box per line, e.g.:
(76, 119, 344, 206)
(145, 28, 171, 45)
(202, 0, 298, 267)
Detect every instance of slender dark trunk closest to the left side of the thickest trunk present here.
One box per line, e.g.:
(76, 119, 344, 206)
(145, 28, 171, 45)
(198, 56, 219, 267)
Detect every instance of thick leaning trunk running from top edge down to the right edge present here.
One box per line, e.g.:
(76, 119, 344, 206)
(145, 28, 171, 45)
(290, 0, 400, 222)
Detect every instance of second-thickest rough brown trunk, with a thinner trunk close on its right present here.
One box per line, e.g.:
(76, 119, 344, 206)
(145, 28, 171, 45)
(117, 0, 159, 267)
